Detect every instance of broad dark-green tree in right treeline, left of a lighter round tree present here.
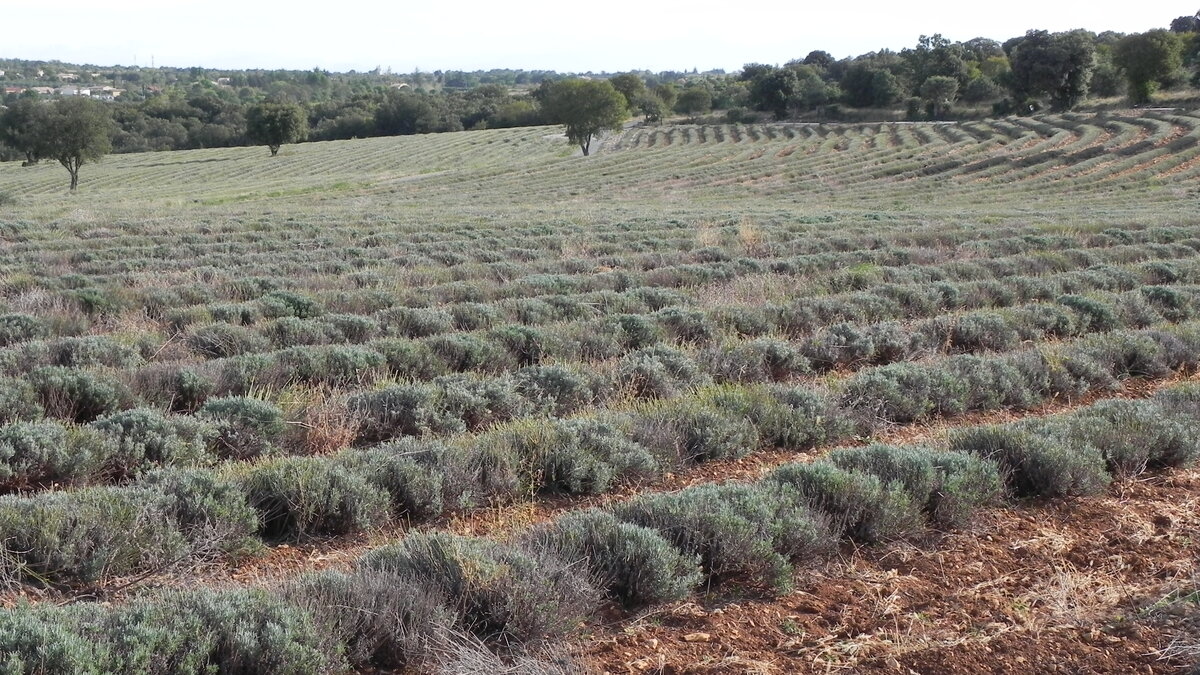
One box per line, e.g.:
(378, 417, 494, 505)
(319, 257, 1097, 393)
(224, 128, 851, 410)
(1004, 30, 1096, 110)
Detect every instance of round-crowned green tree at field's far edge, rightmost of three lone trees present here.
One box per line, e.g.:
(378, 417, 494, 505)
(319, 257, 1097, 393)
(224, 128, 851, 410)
(542, 79, 629, 156)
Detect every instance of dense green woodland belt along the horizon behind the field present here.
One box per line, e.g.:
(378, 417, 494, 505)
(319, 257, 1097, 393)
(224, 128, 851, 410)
(0, 9, 1200, 160)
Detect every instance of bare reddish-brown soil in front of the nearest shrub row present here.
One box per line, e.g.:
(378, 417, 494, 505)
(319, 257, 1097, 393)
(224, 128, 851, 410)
(575, 471, 1200, 674)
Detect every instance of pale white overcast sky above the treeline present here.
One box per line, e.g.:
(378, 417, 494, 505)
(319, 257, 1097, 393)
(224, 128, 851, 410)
(0, 0, 1200, 72)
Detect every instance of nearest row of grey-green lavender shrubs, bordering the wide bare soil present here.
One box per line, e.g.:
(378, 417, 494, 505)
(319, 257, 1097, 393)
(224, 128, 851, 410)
(0, 383, 1200, 674)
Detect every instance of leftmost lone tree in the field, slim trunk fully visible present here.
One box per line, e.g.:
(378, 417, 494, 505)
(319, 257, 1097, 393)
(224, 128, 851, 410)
(40, 96, 114, 191)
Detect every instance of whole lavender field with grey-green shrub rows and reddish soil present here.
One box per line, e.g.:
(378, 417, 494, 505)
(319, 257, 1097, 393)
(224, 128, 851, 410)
(0, 112, 1200, 673)
